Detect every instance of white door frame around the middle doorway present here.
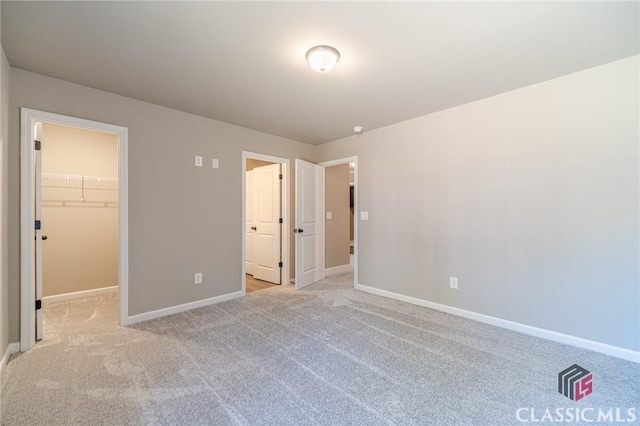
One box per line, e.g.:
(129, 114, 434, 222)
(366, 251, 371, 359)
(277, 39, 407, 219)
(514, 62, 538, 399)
(240, 151, 291, 296)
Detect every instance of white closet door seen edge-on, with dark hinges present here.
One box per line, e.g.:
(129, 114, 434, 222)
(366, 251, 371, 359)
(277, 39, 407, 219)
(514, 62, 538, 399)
(33, 122, 42, 340)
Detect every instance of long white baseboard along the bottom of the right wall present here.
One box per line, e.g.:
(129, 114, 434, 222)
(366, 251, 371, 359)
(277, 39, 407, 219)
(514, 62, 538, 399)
(355, 284, 640, 363)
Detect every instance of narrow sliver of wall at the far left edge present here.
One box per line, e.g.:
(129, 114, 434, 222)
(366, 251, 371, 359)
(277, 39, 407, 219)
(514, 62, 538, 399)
(0, 46, 10, 358)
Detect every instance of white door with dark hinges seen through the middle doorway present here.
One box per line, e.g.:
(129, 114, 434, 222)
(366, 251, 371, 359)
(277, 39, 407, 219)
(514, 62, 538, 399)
(253, 164, 282, 284)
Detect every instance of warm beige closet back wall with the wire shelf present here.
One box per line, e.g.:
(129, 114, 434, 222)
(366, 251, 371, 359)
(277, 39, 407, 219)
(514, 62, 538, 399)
(42, 123, 118, 297)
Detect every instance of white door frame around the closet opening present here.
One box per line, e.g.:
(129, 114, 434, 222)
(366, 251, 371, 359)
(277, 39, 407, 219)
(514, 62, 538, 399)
(20, 108, 129, 352)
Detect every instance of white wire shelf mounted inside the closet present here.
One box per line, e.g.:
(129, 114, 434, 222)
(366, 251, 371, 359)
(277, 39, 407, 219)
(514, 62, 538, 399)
(42, 173, 118, 206)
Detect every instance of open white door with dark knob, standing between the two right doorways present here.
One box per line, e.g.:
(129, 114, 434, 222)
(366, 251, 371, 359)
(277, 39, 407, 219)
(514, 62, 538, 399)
(293, 159, 324, 290)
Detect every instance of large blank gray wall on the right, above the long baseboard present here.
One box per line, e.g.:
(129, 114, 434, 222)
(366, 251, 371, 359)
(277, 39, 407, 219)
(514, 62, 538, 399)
(318, 56, 640, 351)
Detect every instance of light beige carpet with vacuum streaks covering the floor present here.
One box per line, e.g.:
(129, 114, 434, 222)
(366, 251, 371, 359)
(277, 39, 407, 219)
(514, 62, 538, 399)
(0, 274, 640, 425)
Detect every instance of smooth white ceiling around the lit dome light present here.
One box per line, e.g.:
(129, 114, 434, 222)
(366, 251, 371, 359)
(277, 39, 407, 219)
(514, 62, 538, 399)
(2, 1, 640, 144)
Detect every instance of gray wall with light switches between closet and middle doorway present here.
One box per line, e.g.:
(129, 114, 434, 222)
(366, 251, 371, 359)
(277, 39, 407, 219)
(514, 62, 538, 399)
(9, 69, 314, 341)
